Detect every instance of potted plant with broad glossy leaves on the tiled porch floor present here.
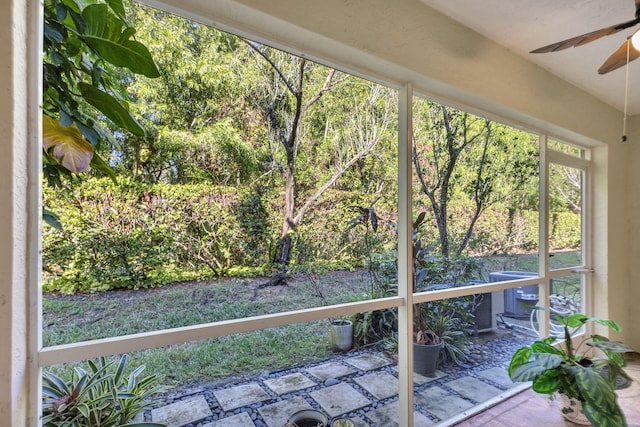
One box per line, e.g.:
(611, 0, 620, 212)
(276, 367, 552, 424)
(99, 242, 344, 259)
(509, 313, 633, 426)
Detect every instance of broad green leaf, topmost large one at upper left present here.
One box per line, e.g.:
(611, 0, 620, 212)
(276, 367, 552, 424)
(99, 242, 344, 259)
(82, 4, 160, 78)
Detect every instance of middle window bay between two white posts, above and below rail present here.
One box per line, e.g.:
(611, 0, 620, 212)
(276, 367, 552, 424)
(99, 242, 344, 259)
(404, 98, 540, 422)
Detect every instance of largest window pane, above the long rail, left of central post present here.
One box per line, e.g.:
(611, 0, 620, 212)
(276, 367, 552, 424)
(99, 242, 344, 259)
(43, 5, 398, 345)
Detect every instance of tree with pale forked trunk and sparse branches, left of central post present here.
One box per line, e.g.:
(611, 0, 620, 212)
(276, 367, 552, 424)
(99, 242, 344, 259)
(243, 42, 395, 283)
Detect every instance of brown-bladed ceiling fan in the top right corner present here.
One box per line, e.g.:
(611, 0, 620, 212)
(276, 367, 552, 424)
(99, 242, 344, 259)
(531, 0, 640, 74)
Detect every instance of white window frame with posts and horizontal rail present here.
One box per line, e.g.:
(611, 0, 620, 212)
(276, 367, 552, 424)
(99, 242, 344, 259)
(29, 1, 591, 427)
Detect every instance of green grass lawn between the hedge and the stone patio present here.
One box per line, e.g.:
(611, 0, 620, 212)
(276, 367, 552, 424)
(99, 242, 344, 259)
(43, 252, 579, 392)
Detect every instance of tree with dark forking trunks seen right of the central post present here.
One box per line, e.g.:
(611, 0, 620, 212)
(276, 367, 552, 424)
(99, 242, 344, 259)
(413, 100, 538, 257)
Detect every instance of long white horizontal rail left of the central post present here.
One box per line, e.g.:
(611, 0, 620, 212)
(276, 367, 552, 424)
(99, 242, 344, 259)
(38, 297, 404, 368)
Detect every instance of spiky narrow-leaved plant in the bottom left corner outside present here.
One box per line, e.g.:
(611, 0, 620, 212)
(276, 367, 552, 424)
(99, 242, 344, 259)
(42, 355, 164, 427)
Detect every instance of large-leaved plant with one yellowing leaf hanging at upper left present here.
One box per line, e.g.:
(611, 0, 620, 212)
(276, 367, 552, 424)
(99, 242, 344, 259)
(43, 0, 160, 179)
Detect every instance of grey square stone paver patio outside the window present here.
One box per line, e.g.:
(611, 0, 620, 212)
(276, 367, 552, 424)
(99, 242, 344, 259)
(145, 352, 514, 427)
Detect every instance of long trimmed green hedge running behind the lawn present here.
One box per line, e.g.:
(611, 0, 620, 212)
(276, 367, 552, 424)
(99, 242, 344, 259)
(42, 179, 580, 293)
